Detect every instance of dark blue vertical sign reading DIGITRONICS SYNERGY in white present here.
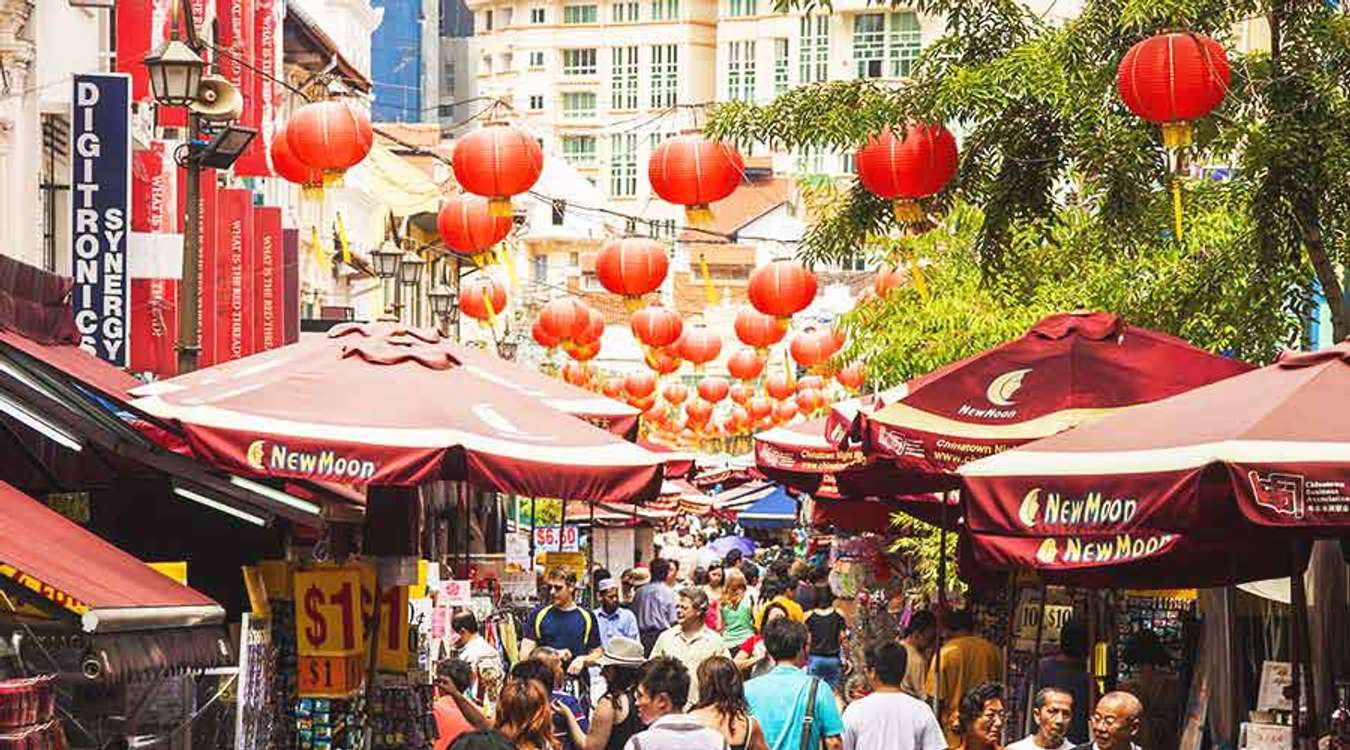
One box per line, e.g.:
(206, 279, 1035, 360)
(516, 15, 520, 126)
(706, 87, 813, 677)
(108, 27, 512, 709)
(70, 73, 131, 367)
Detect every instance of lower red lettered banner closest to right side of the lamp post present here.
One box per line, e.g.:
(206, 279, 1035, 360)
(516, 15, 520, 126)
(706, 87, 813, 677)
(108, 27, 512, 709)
(211, 188, 254, 364)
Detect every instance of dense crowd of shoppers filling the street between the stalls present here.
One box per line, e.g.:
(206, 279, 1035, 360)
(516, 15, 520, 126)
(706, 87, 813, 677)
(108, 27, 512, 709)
(435, 550, 1162, 750)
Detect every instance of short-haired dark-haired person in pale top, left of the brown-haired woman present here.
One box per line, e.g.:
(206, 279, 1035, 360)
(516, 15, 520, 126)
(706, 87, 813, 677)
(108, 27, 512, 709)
(624, 657, 726, 750)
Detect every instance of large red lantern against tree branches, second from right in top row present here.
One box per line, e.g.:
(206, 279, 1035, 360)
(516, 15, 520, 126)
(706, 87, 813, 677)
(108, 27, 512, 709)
(856, 123, 957, 225)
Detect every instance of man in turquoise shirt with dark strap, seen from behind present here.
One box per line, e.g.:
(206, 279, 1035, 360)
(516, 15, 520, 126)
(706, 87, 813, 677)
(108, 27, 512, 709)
(745, 618, 844, 750)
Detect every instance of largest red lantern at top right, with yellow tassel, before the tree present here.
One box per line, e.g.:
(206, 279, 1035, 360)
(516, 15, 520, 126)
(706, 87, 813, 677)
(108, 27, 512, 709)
(1115, 31, 1233, 148)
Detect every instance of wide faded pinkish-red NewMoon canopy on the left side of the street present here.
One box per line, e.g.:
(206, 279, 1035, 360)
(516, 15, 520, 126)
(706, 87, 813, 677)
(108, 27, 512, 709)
(134, 322, 663, 502)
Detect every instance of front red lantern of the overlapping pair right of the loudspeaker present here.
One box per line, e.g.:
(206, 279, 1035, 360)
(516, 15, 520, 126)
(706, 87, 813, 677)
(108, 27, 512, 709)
(286, 98, 375, 181)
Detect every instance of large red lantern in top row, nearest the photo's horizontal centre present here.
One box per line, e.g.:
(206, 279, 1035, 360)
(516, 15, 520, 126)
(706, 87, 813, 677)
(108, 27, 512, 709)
(647, 135, 745, 225)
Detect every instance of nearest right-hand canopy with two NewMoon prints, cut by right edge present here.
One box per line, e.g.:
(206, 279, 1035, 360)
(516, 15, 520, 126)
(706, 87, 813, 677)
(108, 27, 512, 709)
(961, 343, 1350, 583)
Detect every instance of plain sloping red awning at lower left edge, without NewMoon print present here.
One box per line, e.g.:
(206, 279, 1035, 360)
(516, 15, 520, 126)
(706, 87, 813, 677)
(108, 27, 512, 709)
(0, 482, 225, 633)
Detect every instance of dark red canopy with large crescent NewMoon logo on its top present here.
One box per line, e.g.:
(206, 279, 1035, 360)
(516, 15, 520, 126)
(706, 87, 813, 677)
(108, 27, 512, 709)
(863, 313, 1251, 494)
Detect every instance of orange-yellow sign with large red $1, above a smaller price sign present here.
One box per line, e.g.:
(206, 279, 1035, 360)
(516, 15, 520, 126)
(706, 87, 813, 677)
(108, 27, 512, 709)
(294, 568, 366, 656)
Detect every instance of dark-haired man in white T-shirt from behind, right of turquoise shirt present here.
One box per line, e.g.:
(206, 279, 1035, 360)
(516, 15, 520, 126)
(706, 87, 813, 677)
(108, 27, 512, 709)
(844, 641, 946, 750)
